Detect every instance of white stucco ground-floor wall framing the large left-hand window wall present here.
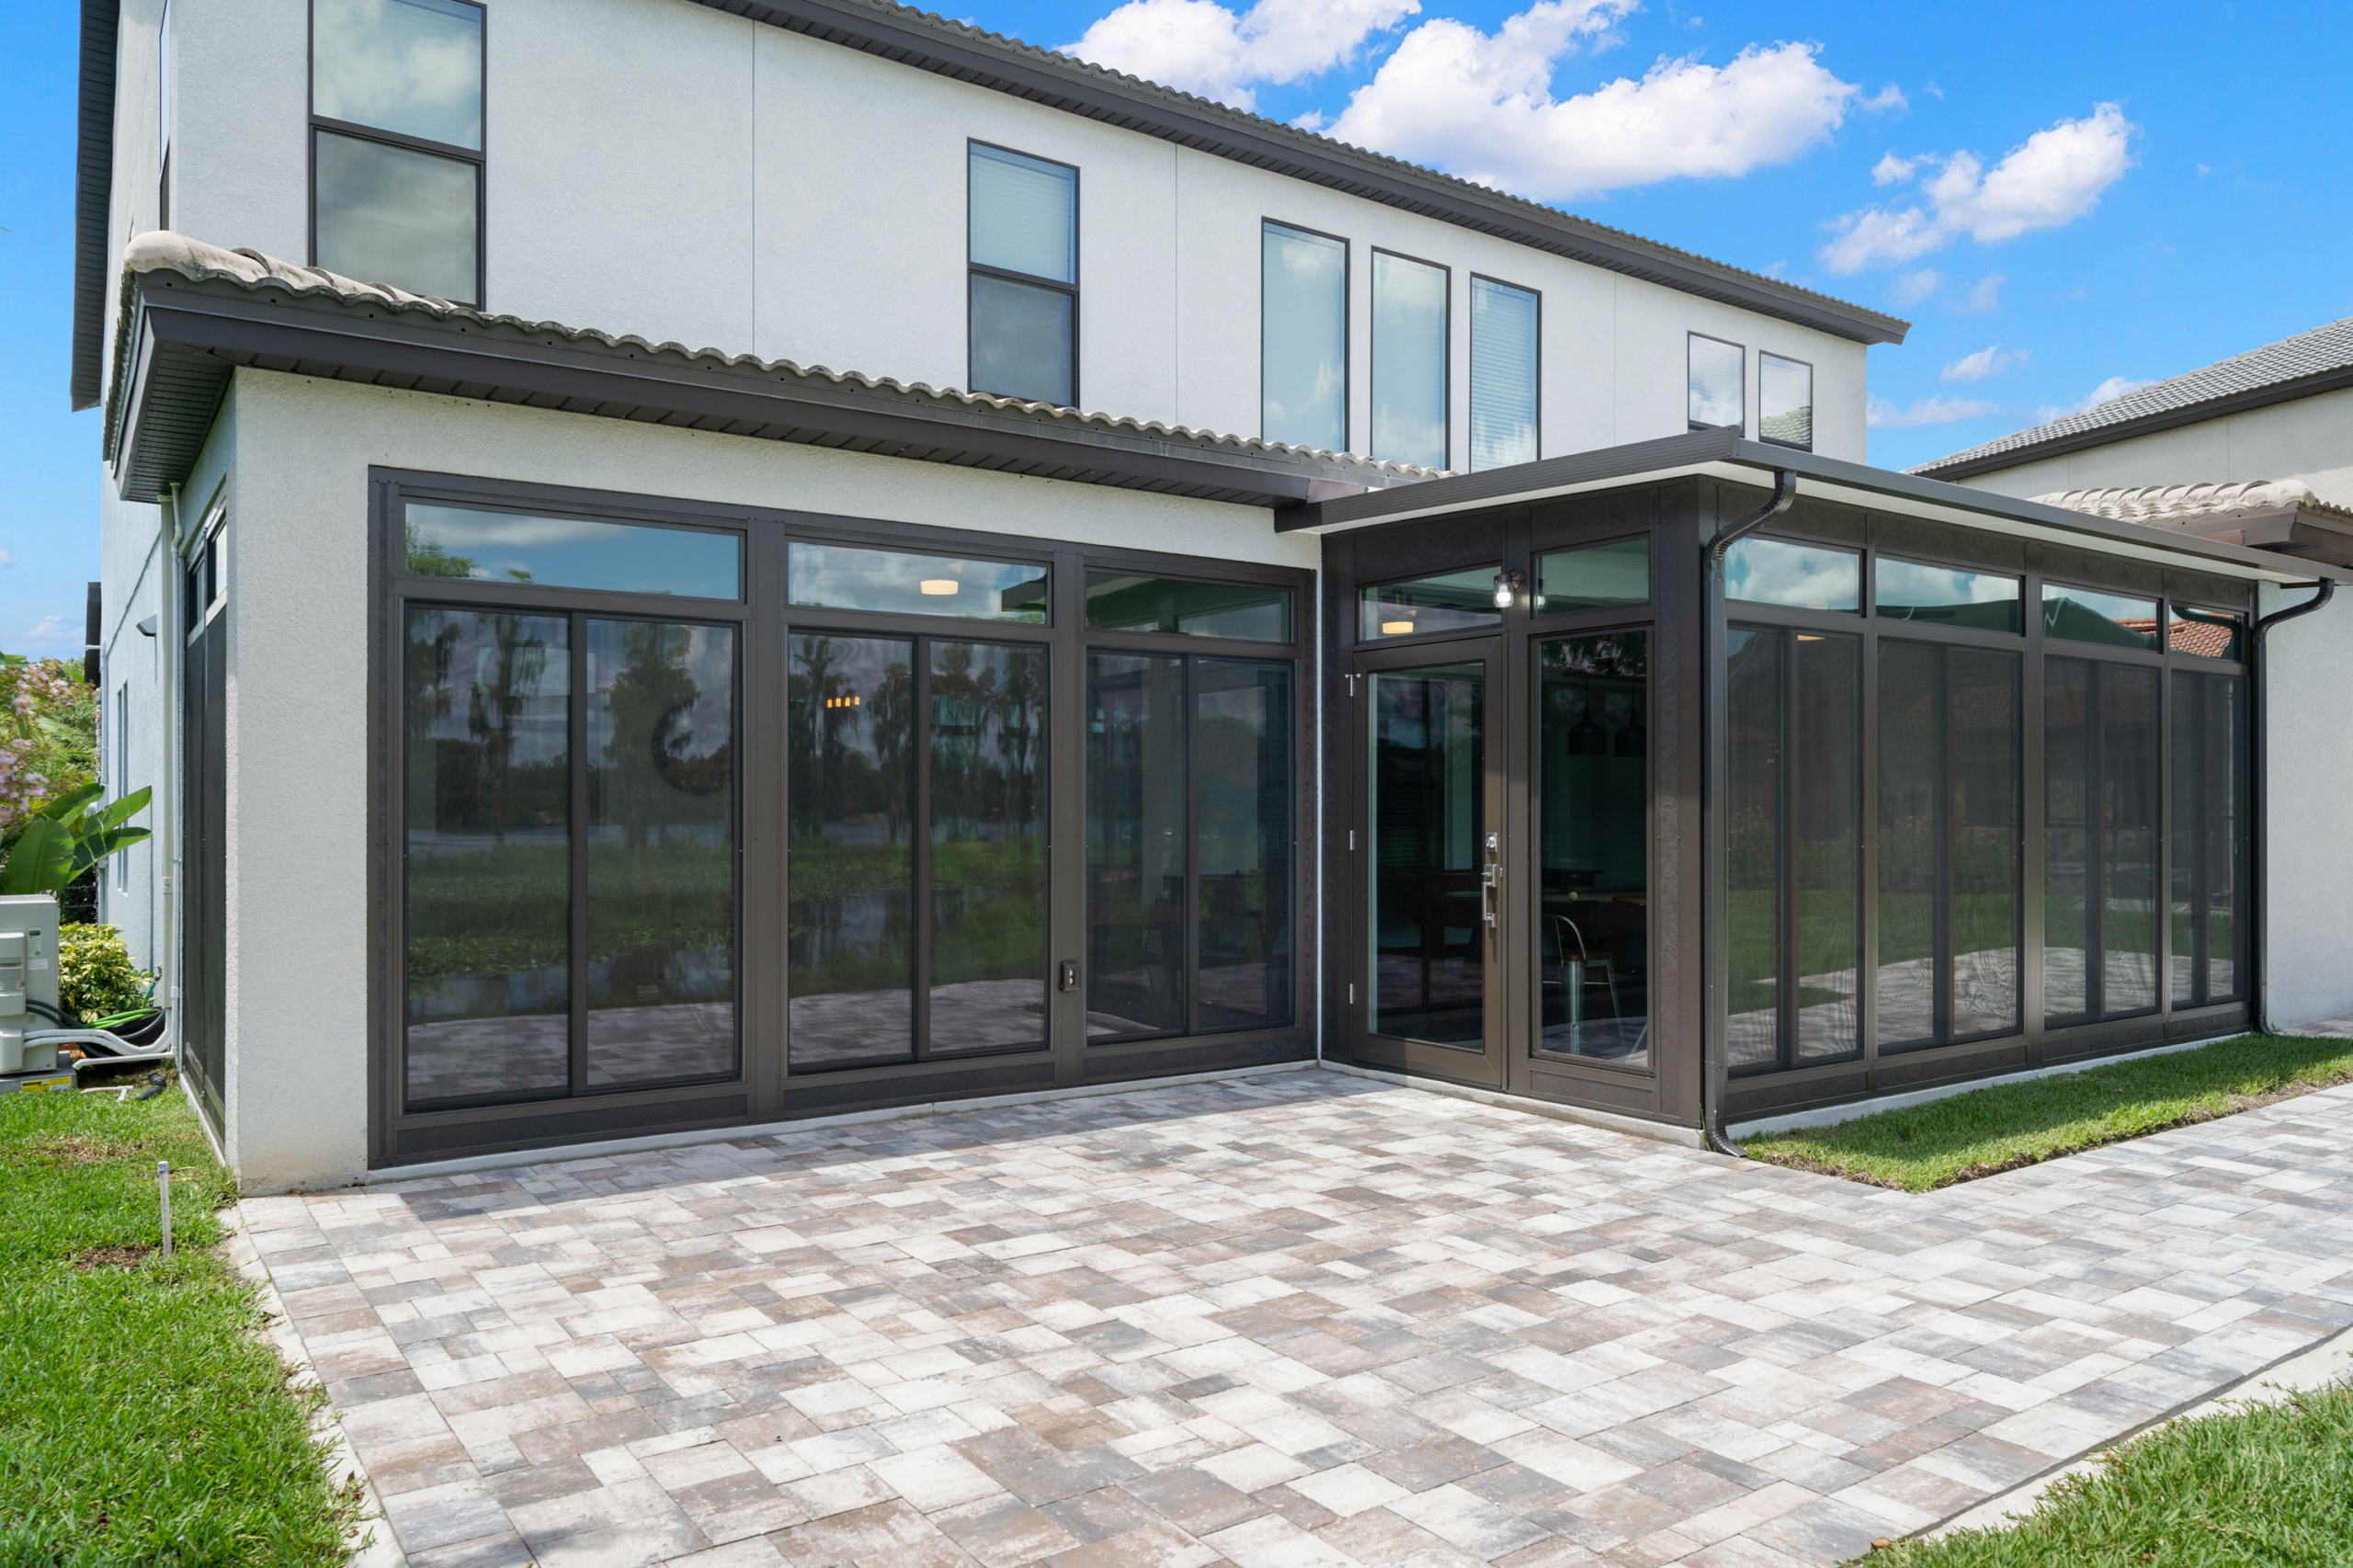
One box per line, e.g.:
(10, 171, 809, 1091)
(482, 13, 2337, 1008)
(190, 359, 1318, 1187)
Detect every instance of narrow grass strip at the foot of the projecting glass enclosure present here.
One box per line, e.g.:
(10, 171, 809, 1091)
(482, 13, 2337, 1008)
(1744, 1034, 2353, 1191)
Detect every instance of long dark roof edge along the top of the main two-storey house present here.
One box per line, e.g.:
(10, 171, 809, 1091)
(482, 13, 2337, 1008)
(697, 0, 1911, 344)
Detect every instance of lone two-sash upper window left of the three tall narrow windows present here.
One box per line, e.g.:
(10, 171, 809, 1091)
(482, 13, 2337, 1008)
(967, 142, 1077, 407)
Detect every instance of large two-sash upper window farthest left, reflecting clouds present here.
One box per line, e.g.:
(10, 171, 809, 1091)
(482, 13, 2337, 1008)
(311, 0, 483, 306)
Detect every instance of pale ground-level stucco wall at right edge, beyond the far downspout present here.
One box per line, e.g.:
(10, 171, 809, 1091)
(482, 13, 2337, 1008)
(2261, 588, 2353, 1031)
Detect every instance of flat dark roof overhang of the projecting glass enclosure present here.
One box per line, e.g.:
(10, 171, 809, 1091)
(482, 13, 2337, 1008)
(1276, 431, 2353, 584)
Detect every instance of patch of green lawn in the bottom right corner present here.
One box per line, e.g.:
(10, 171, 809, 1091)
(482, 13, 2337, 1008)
(1857, 1382, 2353, 1568)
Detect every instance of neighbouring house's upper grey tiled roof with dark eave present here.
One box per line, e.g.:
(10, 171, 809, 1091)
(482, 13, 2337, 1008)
(1913, 315, 2353, 481)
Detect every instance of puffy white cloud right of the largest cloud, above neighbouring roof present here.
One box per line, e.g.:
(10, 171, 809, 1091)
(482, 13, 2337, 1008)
(1821, 104, 2139, 273)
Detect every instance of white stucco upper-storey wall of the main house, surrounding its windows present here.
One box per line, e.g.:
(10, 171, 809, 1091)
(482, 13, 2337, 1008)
(152, 0, 1866, 466)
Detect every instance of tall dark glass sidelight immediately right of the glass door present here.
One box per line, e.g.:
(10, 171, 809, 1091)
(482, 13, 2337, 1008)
(1537, 631, 1650, 1066)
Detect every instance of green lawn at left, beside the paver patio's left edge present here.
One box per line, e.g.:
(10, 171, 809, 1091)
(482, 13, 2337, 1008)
(0, 1068, 353, 1568)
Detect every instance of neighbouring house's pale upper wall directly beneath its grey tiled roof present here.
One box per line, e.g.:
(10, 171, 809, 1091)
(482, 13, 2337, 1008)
(1962, 389, 2353, 506)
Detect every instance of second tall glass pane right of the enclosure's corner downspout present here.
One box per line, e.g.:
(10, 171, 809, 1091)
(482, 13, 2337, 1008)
(1790, 631, 1864, 1066)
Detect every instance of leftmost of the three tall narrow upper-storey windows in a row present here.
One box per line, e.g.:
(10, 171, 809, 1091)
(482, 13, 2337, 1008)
(1259, 223, 1348, 452)
